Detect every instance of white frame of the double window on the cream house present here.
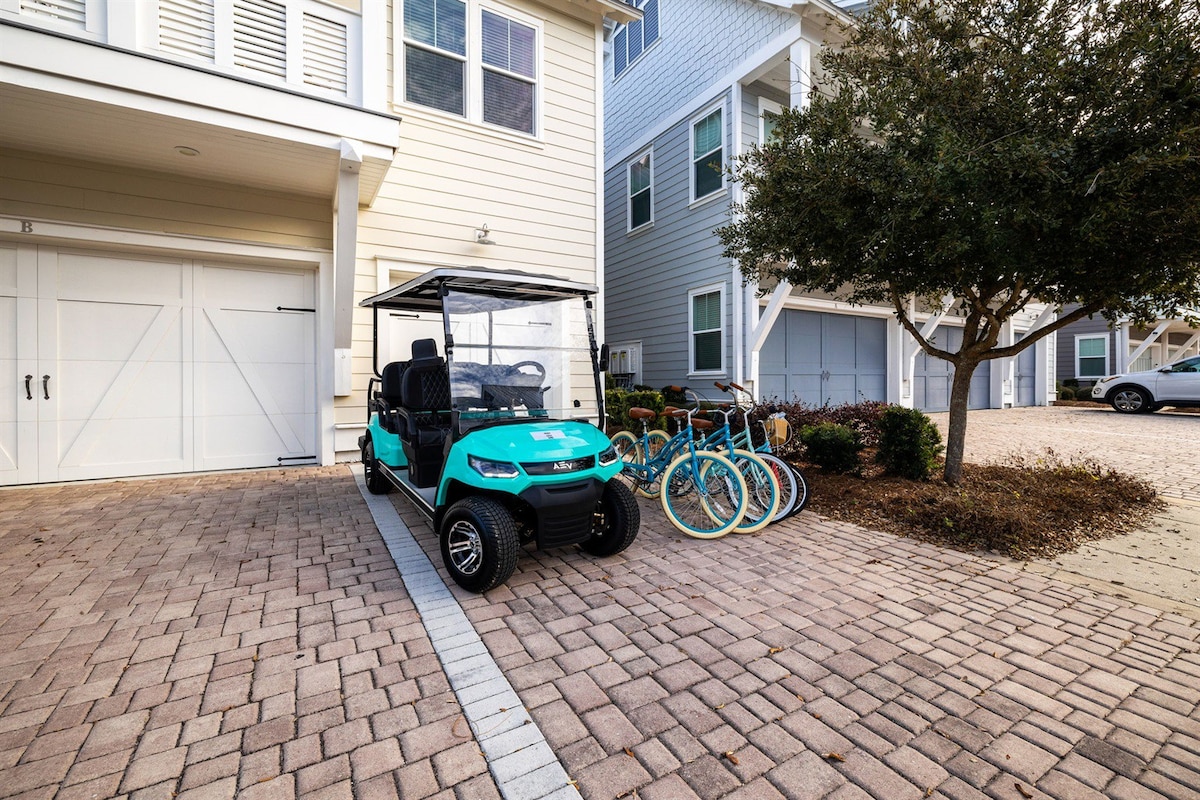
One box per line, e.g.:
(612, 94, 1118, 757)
(392, 0, 546, 140)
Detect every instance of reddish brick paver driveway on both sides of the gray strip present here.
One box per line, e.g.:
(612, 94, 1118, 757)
(0, 429, 1200, 800)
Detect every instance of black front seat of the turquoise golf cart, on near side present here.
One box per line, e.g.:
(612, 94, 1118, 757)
(397, 339, 450, 488)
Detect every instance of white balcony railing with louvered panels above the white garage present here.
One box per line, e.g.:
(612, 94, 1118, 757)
(0, 0, 362, 103)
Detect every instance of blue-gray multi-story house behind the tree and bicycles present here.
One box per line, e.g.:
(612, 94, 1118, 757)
(602, 0, 1055, 410)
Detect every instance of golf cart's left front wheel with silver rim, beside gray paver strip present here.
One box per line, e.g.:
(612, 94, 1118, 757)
(439, 498, 521, 593)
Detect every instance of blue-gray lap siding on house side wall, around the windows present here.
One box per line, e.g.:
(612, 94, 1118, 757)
(605, 97, 733, 386)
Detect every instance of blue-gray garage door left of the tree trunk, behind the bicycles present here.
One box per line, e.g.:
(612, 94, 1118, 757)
(758, 311, 888, 405)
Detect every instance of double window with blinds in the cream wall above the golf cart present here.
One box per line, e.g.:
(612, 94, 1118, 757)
(401, 0, 540, 136)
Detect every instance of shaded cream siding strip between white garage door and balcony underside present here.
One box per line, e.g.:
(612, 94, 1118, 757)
(0, 150, 332, 248)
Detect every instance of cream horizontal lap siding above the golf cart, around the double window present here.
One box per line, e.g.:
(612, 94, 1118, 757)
(350, 1, 599, 423)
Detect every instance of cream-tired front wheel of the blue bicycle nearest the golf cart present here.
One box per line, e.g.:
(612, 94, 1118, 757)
(659, 452, 746, 539)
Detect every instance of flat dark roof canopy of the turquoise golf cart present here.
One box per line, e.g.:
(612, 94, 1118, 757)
(359, 266, 598, 311)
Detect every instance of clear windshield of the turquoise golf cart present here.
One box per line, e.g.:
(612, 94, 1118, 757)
(442, 288, 599, 431)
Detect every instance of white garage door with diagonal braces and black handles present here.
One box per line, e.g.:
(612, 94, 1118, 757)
(0, 245, 317, 483)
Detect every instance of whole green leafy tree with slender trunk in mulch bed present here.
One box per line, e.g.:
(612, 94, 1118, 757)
(718, 0, 1200, 482)
